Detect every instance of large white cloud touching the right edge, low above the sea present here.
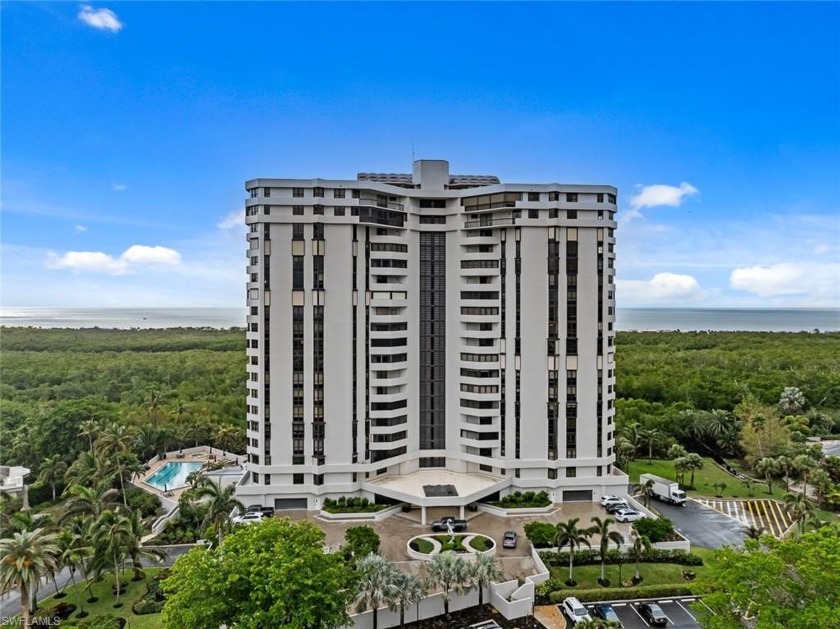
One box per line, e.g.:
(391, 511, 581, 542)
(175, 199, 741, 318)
(729, 262, 840, 305)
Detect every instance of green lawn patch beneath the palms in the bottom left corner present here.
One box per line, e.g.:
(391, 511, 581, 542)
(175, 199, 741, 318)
(38, 568, 163, 629)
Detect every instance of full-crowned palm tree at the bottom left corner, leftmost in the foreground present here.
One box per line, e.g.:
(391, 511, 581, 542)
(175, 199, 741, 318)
(0, 529, 60, 629)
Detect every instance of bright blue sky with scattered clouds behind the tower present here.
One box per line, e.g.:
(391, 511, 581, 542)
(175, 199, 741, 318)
(0, 2, 840, 308)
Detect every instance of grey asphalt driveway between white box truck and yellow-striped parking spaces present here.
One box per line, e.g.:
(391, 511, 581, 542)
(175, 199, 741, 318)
(650, 500, 746, 548)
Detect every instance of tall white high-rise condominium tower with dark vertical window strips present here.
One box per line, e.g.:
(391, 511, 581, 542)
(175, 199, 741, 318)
(238, 160, 627, 515)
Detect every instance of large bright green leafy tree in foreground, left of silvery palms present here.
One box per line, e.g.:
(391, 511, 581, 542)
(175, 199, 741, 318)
(163, 518, 357, 629)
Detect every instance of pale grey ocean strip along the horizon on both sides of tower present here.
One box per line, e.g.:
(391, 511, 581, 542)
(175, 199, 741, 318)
(0, 308, 840, 332)
